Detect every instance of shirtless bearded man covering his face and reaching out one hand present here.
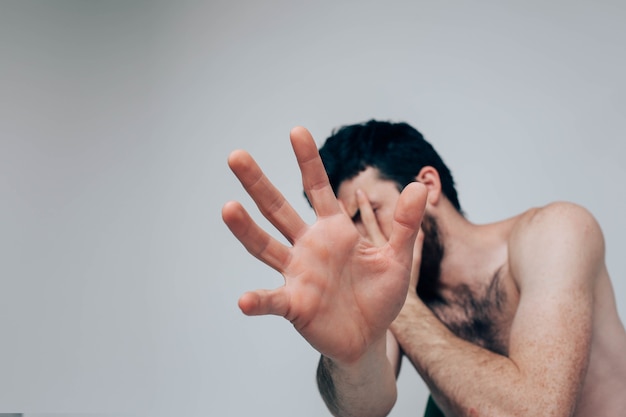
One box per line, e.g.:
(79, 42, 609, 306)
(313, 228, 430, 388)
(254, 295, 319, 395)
(222, 121, 626, 417)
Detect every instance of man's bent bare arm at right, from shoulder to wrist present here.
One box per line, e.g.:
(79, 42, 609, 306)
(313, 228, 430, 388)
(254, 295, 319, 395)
(391, 203, 604, 417)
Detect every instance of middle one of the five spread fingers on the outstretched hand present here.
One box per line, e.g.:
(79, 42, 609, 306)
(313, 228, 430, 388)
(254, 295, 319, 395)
(228, 151, 306, 243)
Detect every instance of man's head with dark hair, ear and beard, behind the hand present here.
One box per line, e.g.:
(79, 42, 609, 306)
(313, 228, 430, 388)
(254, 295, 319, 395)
(320, 120, 462, 301)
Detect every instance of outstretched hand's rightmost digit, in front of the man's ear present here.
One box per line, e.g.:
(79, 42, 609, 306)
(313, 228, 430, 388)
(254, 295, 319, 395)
(389, 182, 428, 257)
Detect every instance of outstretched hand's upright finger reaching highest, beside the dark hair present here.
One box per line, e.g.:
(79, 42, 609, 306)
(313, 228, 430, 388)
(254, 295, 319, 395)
(290, 127, 340, 216)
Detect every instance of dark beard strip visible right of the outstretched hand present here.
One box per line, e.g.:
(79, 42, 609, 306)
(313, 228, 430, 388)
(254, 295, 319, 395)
(417, 214, 443, 303)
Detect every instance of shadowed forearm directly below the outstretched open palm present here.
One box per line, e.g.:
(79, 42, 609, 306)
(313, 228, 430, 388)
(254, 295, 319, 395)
(317, 338, 397, 417)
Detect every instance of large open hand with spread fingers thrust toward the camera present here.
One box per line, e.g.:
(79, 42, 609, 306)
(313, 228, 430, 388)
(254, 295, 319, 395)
(222, 128, 426, 361)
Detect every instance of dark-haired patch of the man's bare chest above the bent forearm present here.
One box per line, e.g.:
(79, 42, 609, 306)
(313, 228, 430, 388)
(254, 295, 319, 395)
(426, 268, 519, 356)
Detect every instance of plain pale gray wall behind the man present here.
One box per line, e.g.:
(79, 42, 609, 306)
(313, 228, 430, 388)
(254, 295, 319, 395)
(0, 0, 626, 417)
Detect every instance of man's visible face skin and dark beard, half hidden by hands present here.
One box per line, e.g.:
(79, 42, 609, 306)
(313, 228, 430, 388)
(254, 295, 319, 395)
(337, 167, 443, 292)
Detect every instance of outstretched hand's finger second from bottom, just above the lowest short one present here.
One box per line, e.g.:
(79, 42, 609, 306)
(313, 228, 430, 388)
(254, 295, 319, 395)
(222, 201, 291, 273)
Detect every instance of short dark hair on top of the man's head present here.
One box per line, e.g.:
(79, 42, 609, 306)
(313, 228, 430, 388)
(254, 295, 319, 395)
(320, 120, 462, 213)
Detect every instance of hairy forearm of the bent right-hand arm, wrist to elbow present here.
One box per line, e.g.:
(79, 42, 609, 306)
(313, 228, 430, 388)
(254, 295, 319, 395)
(391, 301, 569, 417)
